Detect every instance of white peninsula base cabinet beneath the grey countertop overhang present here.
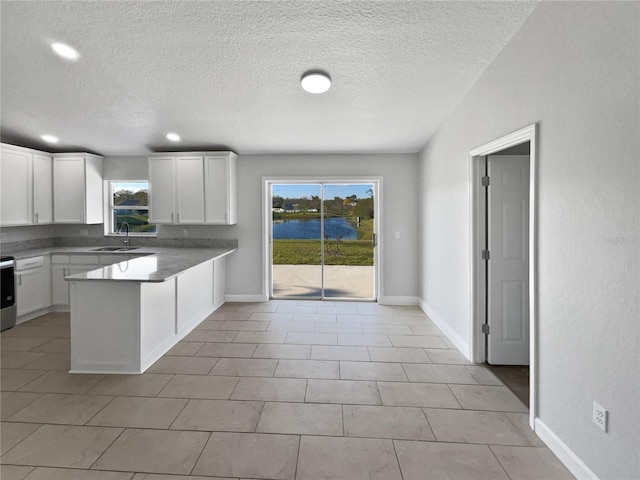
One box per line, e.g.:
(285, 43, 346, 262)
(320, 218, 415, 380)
(70, 258, 225, 373)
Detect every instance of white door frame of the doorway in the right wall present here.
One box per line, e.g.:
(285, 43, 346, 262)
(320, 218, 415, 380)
(469, 123, 539, 430)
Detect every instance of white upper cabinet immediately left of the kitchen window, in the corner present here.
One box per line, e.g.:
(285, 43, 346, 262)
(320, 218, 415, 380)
(53, 153, 103, 224)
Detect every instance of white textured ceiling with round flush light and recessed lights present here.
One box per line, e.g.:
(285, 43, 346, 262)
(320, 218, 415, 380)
(0, 0, 535, 155)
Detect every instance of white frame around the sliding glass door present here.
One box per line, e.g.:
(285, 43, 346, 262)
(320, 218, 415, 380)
(262, 176, 384, 302)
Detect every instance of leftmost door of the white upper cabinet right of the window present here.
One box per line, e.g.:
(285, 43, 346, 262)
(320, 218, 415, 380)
(149, 157, 175, 224)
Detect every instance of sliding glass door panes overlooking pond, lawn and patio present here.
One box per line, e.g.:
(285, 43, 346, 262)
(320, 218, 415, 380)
(267, 179, 379, 301)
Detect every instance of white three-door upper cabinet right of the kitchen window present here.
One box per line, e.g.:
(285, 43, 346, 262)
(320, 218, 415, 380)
(149, 152, 236, 225)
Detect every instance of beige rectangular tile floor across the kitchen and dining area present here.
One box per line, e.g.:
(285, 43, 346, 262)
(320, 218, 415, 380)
(0, 301, 573, 480)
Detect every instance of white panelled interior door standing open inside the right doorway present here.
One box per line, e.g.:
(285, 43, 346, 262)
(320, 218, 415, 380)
(487, 155, 529, 365)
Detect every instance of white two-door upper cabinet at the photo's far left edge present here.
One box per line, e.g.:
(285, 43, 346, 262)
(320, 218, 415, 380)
(0, 144, 53, 226)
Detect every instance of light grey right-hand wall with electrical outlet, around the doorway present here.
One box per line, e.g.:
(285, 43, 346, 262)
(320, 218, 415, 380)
(419, 2, 640, 479)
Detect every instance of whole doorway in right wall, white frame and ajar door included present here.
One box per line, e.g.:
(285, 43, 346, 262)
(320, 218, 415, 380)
(469, 125, 537, 429)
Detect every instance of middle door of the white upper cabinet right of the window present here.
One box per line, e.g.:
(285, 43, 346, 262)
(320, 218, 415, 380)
(175, 157, 204, 225)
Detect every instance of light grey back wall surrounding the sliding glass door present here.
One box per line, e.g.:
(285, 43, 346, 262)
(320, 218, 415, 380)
(211, 154, 418, 297)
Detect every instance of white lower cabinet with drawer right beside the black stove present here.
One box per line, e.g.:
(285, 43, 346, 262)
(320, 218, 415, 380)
(15, 256, 51, 317)
